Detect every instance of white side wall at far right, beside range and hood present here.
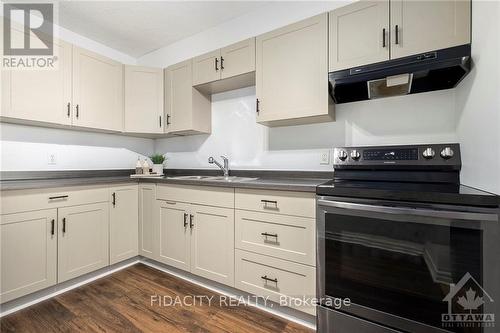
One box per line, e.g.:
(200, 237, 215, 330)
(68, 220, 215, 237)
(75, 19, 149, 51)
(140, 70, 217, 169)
(456, 1, 500, 194)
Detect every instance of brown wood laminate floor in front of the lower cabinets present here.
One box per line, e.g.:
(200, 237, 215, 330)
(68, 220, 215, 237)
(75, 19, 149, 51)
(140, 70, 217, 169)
(0, 264, 312, 333)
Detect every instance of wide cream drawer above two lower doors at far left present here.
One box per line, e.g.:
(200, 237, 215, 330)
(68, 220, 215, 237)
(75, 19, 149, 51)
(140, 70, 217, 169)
(1, 186, 108, 214)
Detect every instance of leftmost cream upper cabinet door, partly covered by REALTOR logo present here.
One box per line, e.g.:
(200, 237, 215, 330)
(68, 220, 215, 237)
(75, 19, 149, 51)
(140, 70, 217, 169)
(1, 30, 72, 125)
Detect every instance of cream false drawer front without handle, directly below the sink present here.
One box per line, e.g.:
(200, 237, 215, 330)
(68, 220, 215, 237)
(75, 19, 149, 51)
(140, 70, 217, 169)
(156, 184, 234, 208)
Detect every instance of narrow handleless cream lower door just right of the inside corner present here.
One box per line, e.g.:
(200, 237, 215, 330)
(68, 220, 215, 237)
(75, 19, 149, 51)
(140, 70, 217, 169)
(139, 184, 157, 259)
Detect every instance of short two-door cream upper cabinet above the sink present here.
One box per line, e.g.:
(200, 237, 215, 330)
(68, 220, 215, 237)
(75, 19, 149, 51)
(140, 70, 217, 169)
(193, 38, 255, 94)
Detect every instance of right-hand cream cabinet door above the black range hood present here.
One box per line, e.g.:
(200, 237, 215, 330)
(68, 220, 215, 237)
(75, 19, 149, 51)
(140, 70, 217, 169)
(391, 0, 471, 59)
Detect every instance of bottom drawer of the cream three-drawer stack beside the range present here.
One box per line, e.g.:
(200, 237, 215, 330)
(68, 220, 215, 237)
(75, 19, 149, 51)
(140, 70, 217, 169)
(235, 250, 316, 315)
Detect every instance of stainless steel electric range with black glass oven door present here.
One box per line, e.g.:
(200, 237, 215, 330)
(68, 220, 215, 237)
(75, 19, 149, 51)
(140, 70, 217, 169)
(317, 144, 500, 333)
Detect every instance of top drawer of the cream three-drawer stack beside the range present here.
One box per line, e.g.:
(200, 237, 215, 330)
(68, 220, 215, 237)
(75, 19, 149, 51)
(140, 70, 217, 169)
(235, 189, 316, 218)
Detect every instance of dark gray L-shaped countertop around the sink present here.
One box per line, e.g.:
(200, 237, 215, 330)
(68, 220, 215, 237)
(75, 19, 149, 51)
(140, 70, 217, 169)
(0, 170, 333, 192)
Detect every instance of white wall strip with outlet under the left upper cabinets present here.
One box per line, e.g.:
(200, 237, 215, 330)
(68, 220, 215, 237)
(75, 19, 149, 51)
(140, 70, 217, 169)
(0, 123, 154, 171)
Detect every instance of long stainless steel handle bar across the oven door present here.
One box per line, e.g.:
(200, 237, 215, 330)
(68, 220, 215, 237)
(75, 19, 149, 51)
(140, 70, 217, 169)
(318, 199, 498, 222)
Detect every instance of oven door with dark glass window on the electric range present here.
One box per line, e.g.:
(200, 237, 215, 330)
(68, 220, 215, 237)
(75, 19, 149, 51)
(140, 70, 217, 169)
(317, 197, 498, 333)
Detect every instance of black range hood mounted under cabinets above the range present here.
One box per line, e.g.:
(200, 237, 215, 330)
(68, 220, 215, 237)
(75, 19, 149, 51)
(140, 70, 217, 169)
(329, 44, 470, 104)
